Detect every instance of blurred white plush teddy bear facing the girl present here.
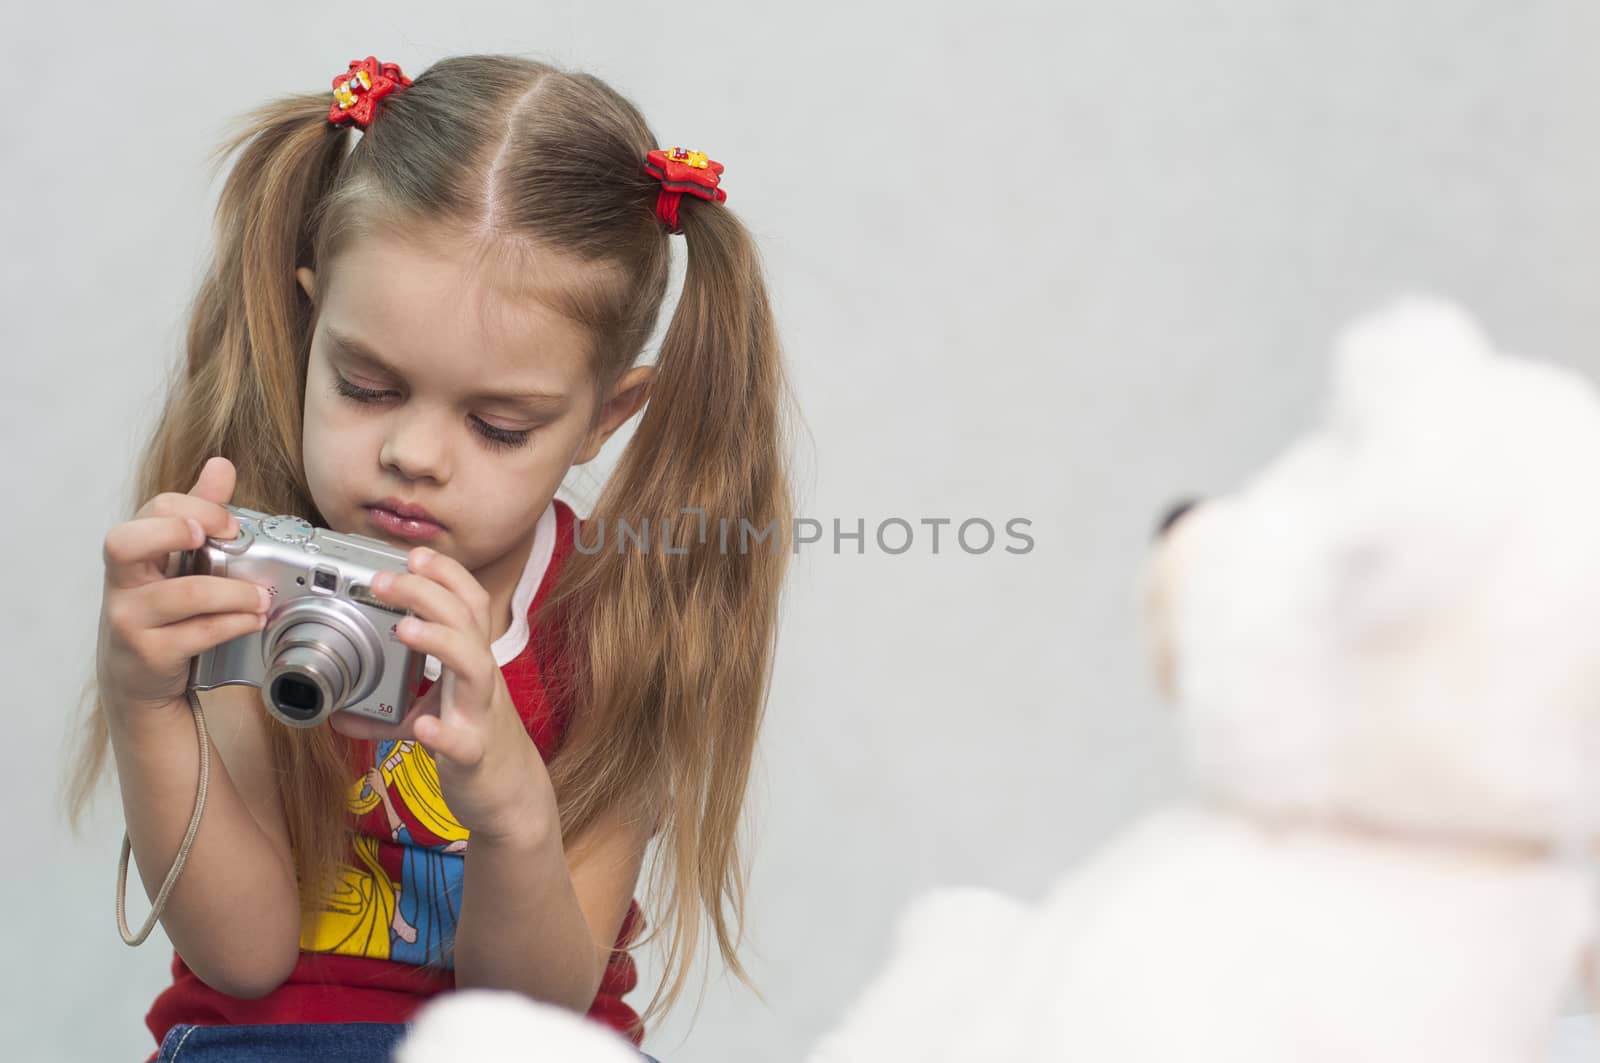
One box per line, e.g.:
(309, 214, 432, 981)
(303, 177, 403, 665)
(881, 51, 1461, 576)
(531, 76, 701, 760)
(810, 299, 1600, 1063)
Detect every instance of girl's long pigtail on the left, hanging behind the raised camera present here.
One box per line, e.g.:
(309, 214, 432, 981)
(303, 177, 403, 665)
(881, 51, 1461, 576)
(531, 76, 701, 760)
(66, 93, 356, 915)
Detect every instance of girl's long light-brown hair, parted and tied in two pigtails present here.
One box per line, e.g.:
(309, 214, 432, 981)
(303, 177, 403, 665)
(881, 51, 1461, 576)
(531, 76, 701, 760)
(66, 56, 792, 1018)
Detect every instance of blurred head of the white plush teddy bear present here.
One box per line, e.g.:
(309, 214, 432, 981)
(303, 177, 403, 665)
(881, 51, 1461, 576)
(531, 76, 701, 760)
(1142, 298, 1600, 844)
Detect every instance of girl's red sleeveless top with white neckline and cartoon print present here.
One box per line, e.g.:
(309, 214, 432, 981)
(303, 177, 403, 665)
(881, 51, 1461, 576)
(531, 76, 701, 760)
(144, 499, 645, 1060)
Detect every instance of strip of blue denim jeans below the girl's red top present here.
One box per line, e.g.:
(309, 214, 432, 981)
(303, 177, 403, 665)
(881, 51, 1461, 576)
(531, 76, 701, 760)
(157, 1023, 658, 1063)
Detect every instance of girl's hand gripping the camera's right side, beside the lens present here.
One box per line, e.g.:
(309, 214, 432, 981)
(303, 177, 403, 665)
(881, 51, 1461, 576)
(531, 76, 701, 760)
(333, 546, 558, 840)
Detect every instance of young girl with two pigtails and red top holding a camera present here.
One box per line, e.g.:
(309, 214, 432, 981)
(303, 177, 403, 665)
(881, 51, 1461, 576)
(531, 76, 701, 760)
(70, 56, 792, 1060)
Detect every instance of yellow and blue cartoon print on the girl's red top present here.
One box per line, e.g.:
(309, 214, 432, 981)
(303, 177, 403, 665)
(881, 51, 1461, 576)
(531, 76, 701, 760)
(301, 740, 469, 969)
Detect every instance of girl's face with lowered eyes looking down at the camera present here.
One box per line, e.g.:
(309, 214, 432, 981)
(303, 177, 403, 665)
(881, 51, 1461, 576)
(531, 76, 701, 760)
(296, 235, 620, 614)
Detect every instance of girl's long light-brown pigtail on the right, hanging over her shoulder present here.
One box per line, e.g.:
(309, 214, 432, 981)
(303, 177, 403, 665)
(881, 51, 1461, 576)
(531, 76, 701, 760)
(550, 200, 792, 1017)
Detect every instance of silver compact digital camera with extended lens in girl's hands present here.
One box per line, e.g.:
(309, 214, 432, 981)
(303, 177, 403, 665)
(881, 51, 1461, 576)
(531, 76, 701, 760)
(178, 506, 427, 727)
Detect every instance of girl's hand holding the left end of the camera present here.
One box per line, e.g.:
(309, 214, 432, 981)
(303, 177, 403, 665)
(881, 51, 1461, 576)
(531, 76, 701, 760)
(96, 458, 269, 714)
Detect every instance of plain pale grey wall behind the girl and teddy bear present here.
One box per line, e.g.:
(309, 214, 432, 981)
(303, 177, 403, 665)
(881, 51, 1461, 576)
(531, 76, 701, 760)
(0, 0, 1600, 1061)
